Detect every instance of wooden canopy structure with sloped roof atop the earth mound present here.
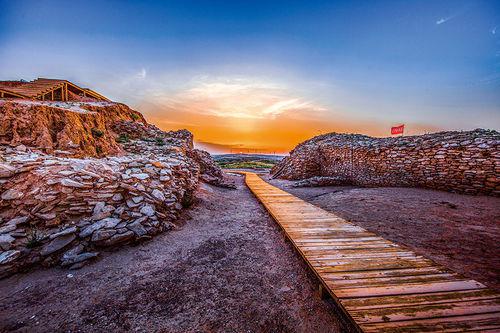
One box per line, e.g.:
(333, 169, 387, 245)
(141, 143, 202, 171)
(0, 78, 110, 102)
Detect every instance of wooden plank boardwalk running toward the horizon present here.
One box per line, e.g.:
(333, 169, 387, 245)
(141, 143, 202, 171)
(245, 173, 500, 332)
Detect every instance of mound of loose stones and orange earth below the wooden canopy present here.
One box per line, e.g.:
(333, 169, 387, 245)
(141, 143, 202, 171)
(0, 102, 223, 277)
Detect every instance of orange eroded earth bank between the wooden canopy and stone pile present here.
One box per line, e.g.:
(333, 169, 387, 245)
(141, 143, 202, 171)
(0, 101, 147, 157)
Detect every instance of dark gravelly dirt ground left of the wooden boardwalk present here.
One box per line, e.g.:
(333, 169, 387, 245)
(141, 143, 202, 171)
(0, 177, 340, 332)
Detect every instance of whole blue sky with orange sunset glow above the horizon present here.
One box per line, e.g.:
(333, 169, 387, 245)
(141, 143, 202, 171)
(0, 0, 500, 153)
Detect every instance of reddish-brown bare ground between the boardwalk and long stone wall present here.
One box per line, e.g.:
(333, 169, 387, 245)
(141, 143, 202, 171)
(265, 177, 500, 291)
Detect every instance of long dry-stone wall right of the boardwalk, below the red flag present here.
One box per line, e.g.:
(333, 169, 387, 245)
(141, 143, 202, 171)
(271, 129, 500, 196)
